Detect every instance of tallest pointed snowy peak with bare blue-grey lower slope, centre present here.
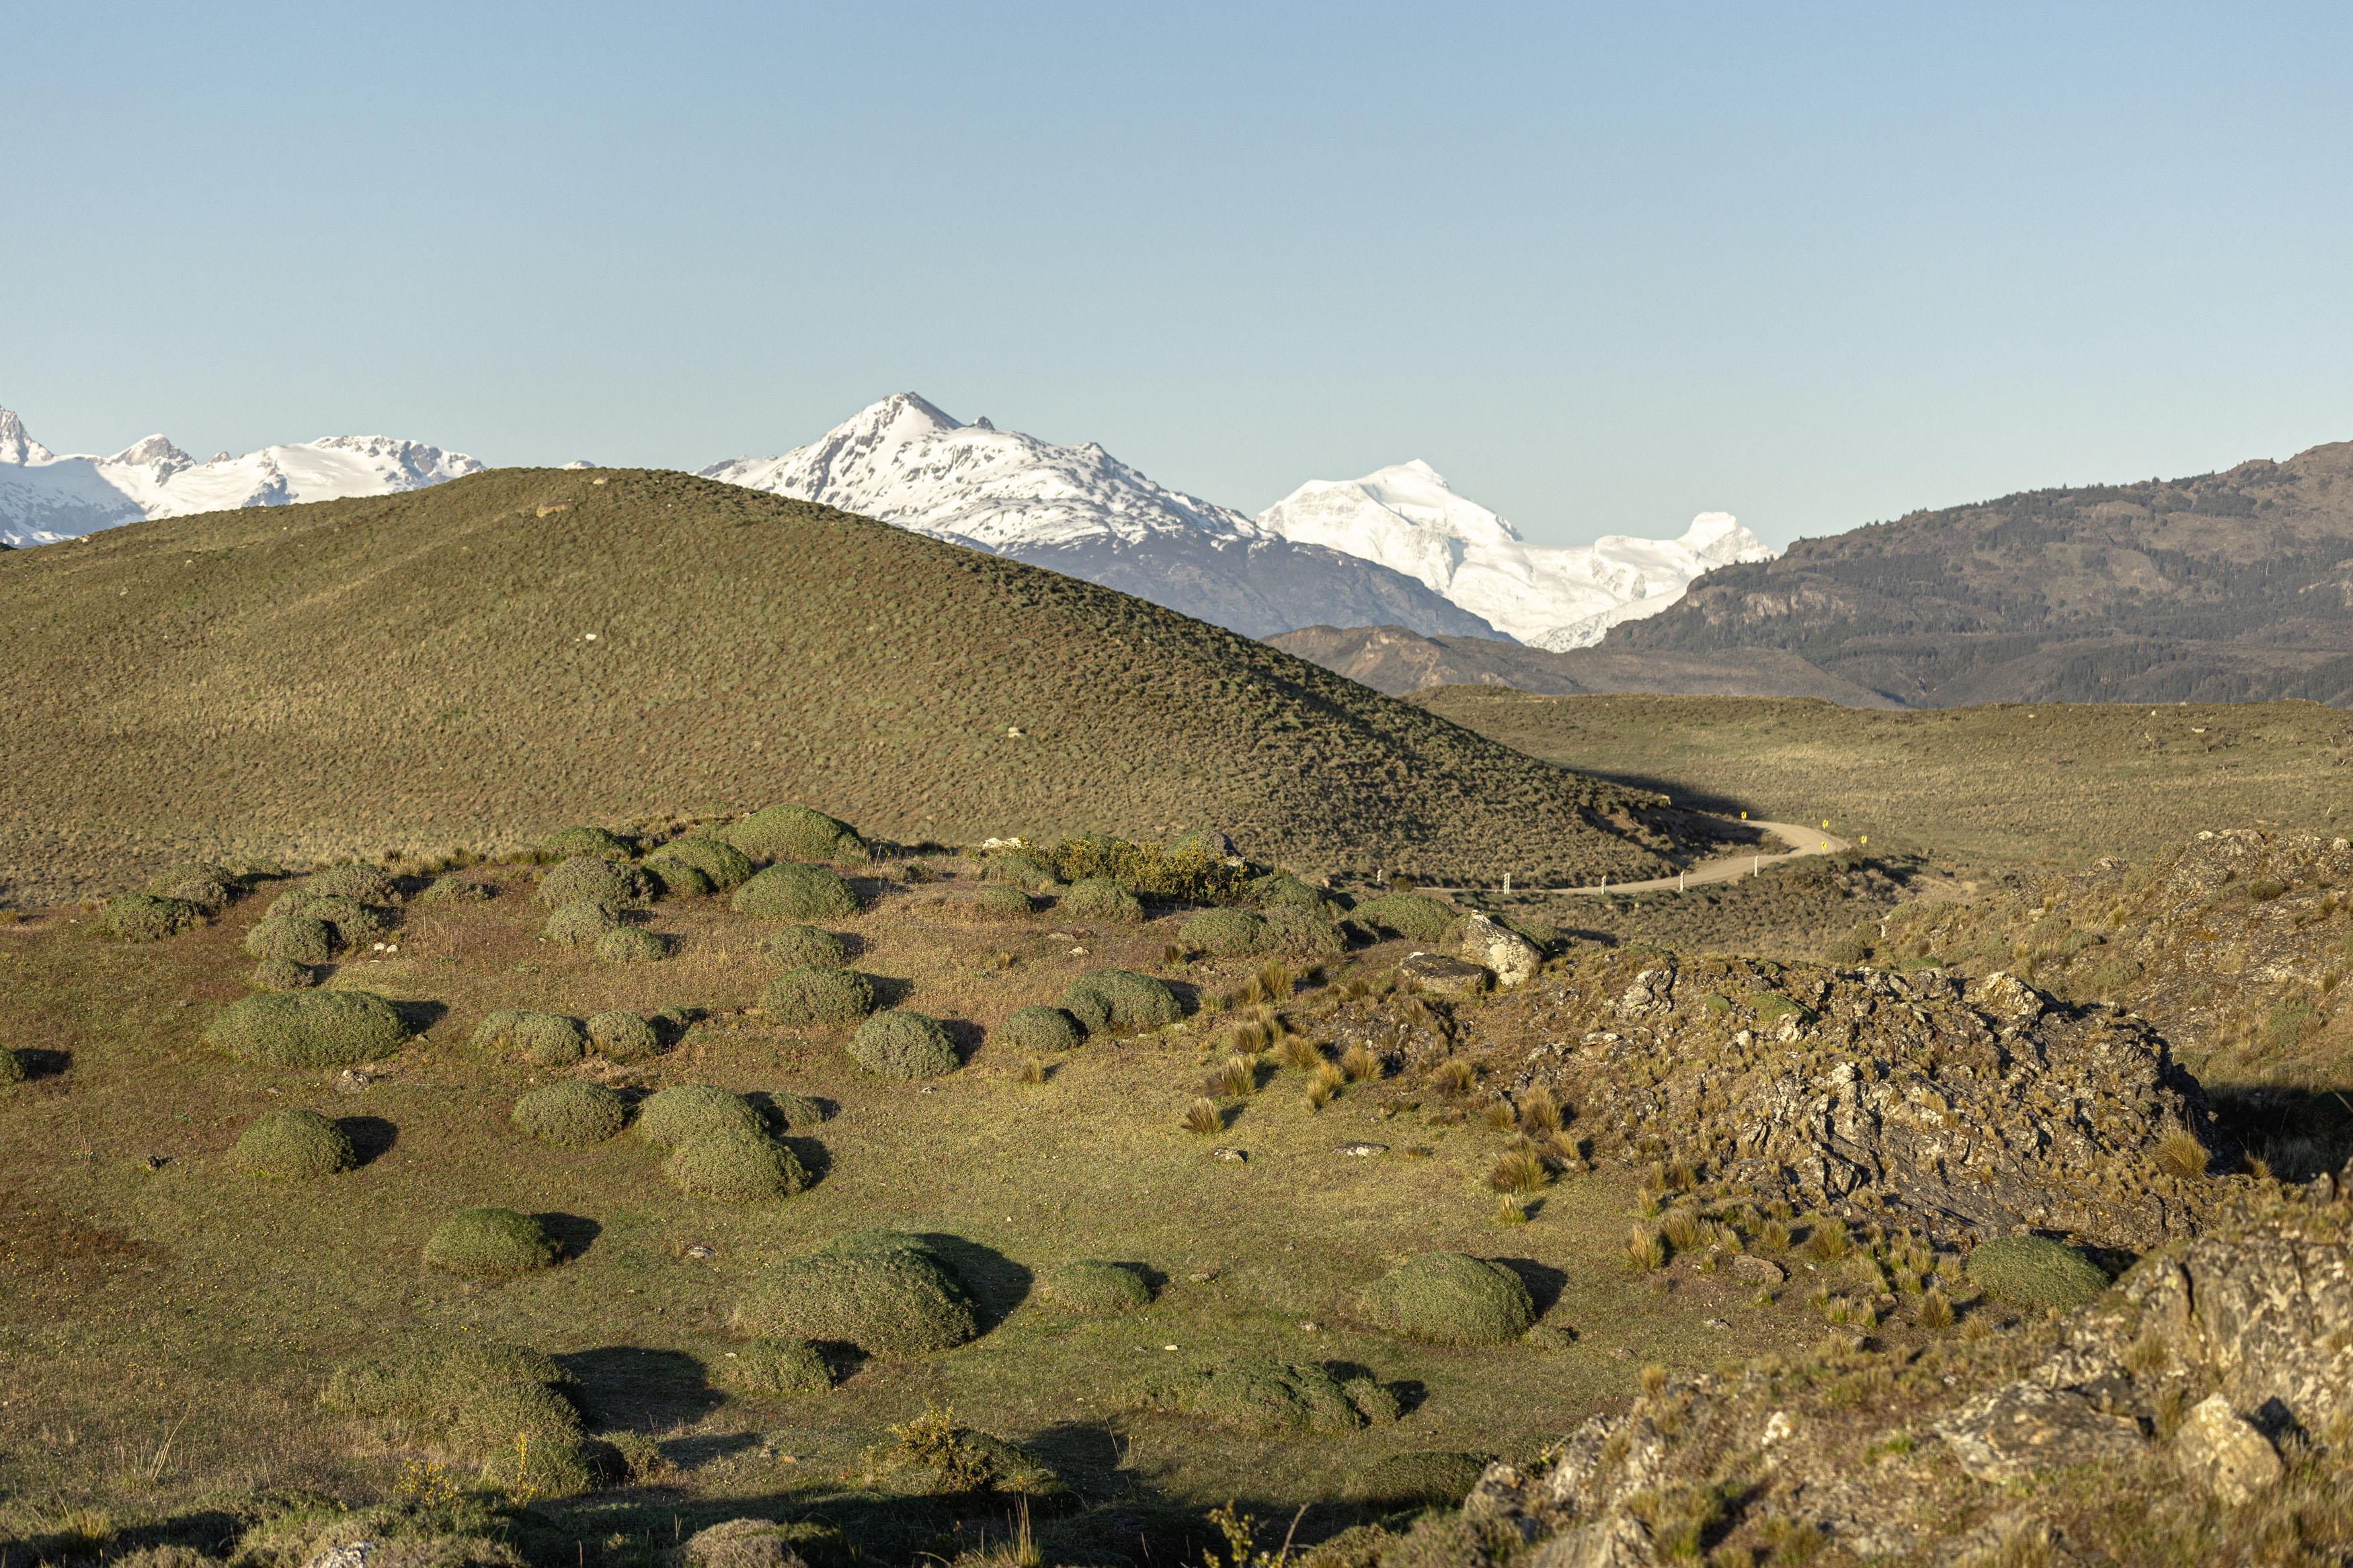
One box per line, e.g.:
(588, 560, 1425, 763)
(699, 393, 1497, 637)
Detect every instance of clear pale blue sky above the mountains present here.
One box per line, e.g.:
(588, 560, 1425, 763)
(0, 0, 2353, 543)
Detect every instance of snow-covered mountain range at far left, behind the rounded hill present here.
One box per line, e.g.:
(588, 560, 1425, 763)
(0, 409, 483, 548)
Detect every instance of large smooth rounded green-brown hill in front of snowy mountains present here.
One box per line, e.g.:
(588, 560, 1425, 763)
(0, 470, 1671, 903)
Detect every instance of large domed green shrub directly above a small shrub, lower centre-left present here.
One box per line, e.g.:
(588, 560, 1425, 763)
(729, 1232, 979, 1361)
